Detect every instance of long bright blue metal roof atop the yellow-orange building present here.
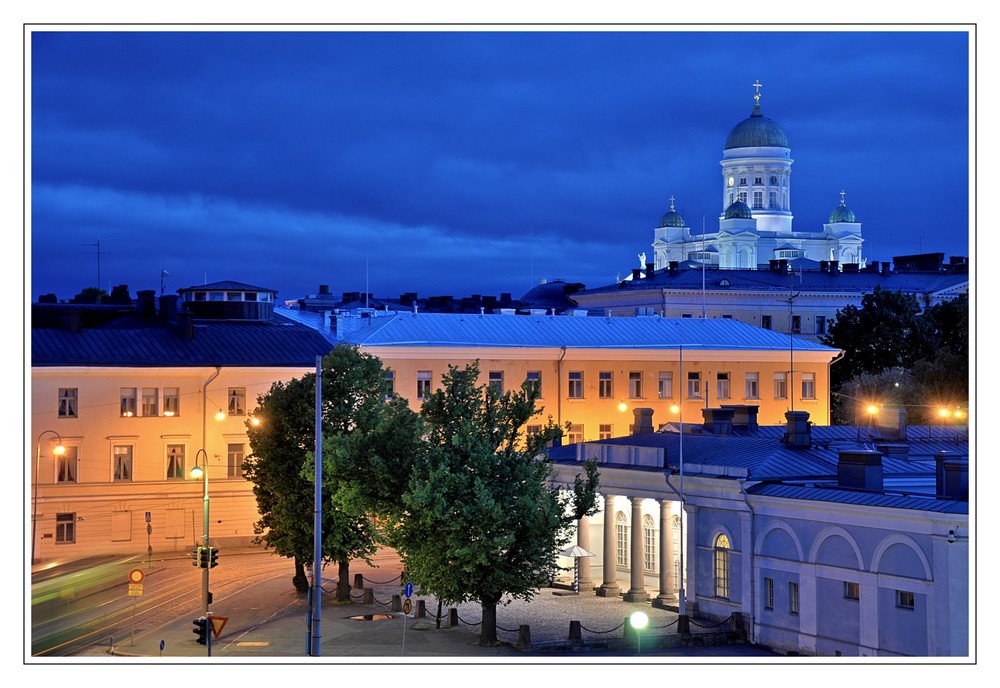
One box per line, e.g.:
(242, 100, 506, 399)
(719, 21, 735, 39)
(345, 313, 837, 357)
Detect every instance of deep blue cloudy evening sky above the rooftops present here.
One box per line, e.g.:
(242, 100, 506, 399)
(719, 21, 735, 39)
(25, 25, 975, 300)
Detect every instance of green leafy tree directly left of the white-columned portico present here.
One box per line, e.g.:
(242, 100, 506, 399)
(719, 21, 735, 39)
(393, 364, 597, 645)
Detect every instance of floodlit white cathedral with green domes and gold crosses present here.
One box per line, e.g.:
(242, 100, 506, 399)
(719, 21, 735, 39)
(652, 81, 864, 270)
